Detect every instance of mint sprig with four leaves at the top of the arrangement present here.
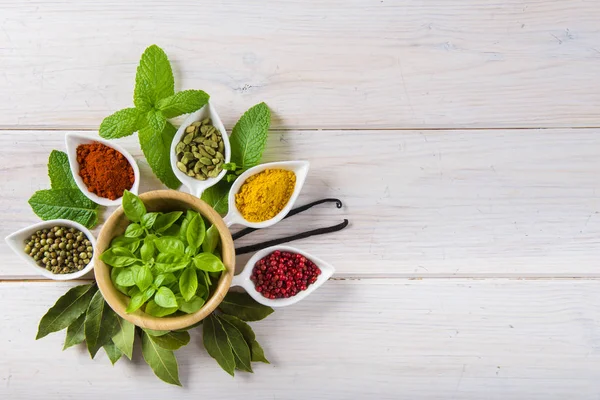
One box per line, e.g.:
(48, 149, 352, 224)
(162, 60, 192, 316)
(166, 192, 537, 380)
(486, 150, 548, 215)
(100, 45, 209, 189)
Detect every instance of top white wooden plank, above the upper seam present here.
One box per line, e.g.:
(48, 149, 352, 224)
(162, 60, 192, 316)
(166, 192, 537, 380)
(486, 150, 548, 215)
(0, 0, 600, 129)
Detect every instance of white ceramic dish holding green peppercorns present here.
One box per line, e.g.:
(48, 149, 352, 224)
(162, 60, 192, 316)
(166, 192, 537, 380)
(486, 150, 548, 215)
(5, 219, 96, 281)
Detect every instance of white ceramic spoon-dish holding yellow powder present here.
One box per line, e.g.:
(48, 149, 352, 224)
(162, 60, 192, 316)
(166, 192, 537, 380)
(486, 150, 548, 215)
(223, 161, 310, 229)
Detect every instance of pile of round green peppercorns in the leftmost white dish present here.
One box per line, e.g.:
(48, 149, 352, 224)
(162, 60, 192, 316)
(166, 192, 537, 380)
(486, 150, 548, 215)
(24, 226, 94, 274)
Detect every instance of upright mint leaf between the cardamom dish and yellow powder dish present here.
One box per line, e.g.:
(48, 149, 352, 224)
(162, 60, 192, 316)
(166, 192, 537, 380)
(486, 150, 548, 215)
(229, 103, 271, 170)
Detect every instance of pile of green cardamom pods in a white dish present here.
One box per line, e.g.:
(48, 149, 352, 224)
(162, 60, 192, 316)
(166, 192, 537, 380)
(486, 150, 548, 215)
(175, 118, 225, 181)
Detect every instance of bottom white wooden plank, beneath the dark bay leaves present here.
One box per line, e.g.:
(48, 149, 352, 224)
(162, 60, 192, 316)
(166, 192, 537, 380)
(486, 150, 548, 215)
(0, 279, 600, 400)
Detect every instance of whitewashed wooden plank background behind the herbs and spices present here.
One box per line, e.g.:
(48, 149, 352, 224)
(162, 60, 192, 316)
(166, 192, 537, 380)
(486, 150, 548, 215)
(0, 0, 600, 399)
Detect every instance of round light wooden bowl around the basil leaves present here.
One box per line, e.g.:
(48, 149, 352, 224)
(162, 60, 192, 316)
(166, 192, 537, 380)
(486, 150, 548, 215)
(94, 190, 235, 330)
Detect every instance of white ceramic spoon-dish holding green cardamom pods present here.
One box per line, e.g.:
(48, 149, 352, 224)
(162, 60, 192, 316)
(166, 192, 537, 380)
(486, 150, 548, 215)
(171, 101, 231, 197)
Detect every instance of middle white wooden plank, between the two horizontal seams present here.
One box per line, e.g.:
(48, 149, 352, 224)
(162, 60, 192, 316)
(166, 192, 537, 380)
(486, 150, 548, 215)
(0, 129, 600, 278)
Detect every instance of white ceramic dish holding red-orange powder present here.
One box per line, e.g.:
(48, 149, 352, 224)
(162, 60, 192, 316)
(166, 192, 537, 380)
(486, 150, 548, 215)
(65, 133, 140, 207)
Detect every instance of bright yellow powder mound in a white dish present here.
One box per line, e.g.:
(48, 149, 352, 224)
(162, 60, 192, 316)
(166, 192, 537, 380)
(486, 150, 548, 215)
(235, 169, 296, 222)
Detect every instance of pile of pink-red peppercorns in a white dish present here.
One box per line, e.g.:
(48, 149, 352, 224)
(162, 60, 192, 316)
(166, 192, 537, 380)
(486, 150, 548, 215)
(250, 250, 321, 299)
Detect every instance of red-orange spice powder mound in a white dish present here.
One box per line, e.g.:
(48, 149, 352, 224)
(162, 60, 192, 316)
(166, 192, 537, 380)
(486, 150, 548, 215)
(77, 142, 135, 200)
